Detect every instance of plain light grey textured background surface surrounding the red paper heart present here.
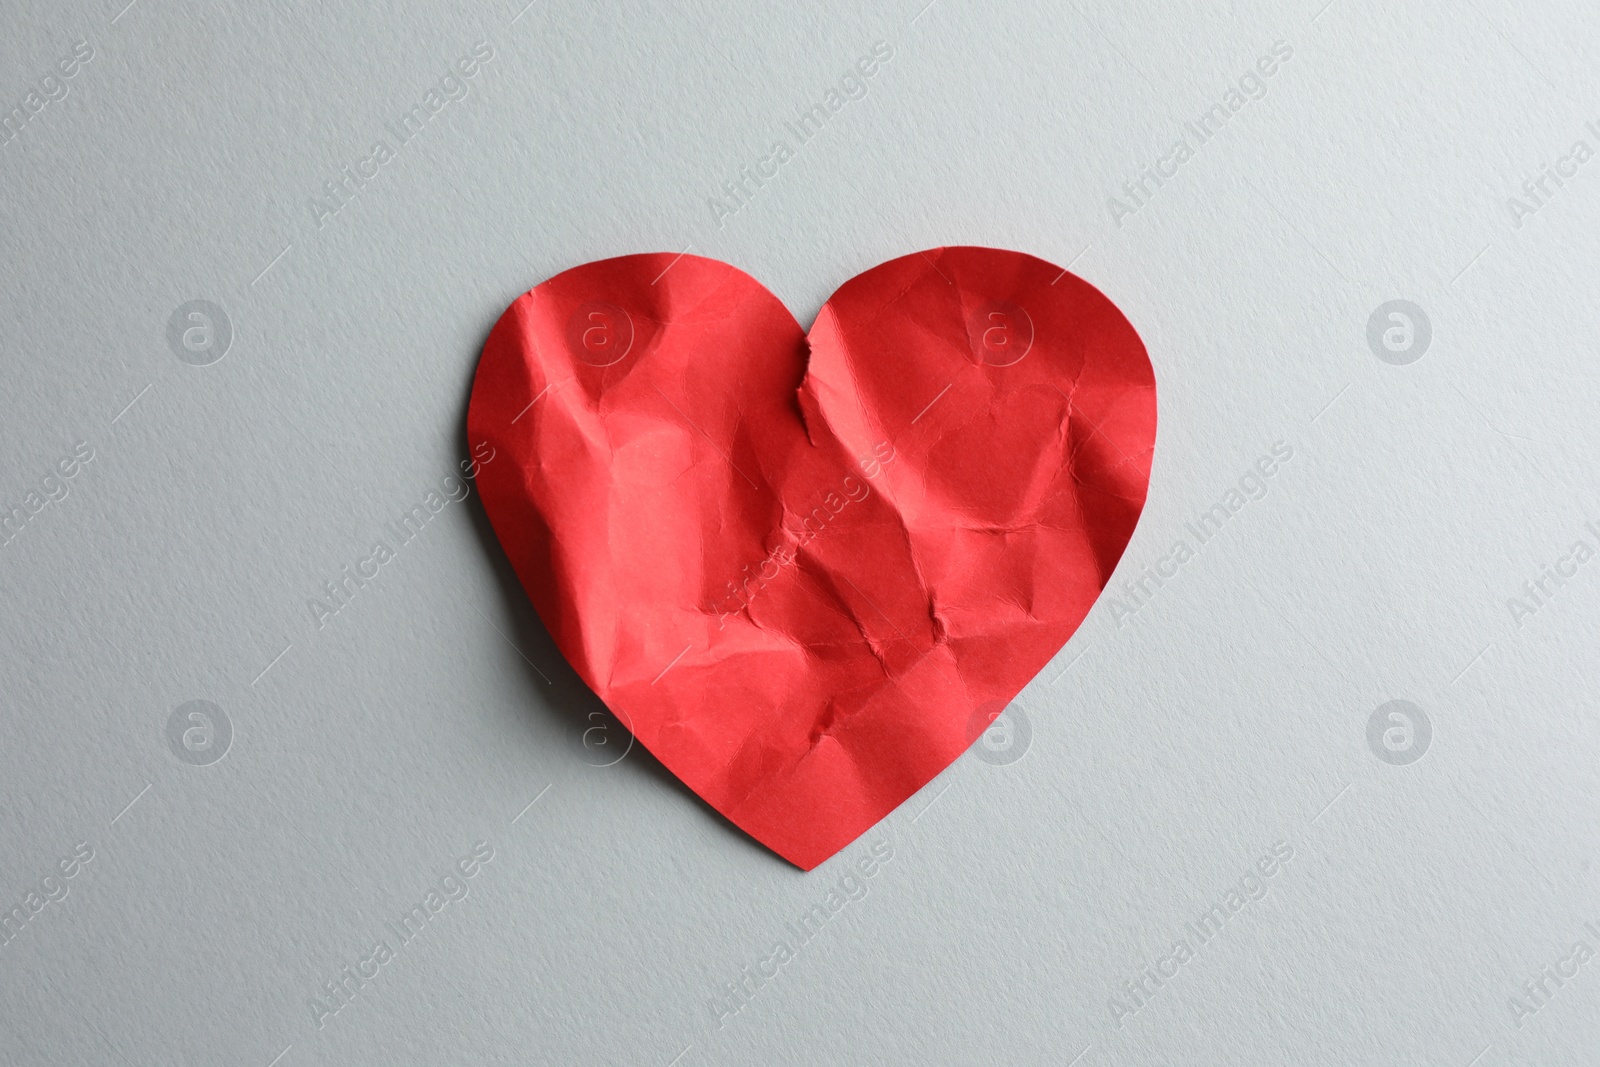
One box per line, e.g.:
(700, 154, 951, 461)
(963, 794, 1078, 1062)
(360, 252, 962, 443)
(0, 0, 1600, 1067)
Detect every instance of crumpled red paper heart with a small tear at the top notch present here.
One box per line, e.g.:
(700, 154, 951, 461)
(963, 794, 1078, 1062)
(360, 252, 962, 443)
(467, 248, 1155, 870)
